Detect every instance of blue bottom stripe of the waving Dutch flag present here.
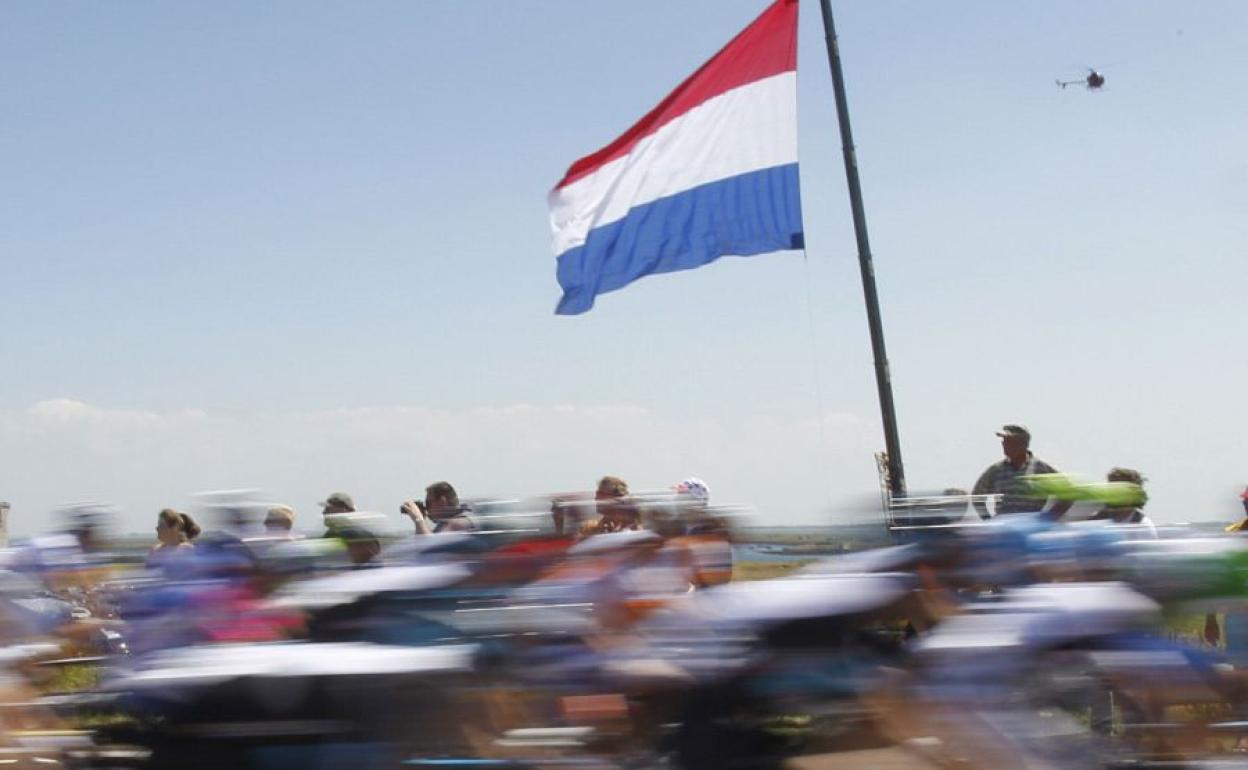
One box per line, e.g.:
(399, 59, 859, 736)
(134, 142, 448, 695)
(554, 163, 804, 316)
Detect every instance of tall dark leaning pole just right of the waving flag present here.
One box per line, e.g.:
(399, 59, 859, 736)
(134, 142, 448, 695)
(820, 0, 906, 495)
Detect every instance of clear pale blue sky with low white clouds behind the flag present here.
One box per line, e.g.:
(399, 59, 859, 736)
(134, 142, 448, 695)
(0, 0, 1248, 532)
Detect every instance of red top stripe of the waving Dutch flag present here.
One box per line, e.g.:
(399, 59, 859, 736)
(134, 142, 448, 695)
(555, 0, 797, 190)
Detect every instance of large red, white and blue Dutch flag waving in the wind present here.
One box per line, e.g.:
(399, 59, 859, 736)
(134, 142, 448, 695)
(549, 0, 802, 314)
